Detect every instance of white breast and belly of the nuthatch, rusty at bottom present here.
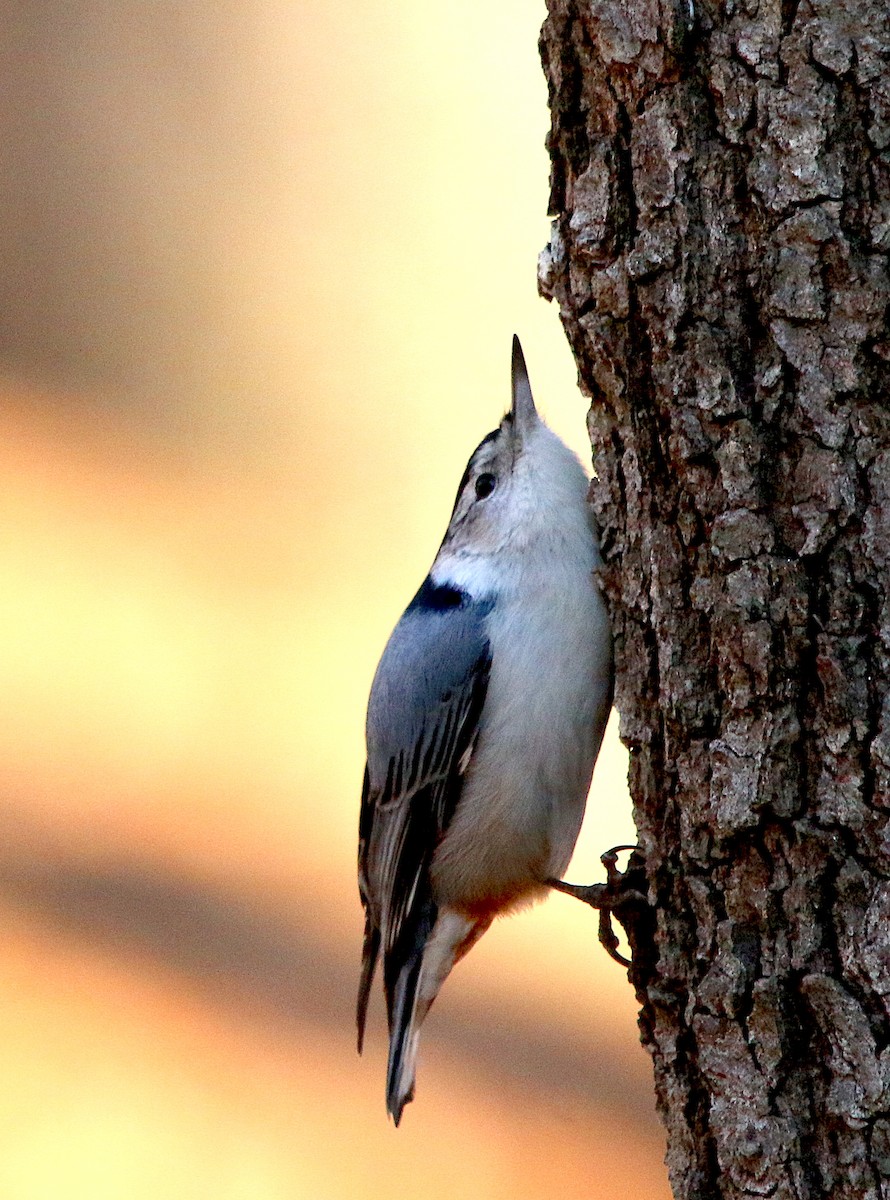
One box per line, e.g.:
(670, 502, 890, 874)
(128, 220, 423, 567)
(432, 549, 612, 911)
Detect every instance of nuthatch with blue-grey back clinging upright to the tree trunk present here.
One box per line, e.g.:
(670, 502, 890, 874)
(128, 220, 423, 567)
(356, 336, 613, 1126)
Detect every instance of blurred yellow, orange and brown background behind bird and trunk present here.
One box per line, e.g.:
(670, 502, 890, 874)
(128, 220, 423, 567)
(0, 0, 668, 1200)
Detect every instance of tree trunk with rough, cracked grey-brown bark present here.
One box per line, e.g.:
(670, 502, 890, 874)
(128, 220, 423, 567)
(540, 0, 890, 1200)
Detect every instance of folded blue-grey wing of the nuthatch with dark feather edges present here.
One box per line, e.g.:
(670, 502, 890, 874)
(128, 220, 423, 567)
(357, 581, 492, 1049)
